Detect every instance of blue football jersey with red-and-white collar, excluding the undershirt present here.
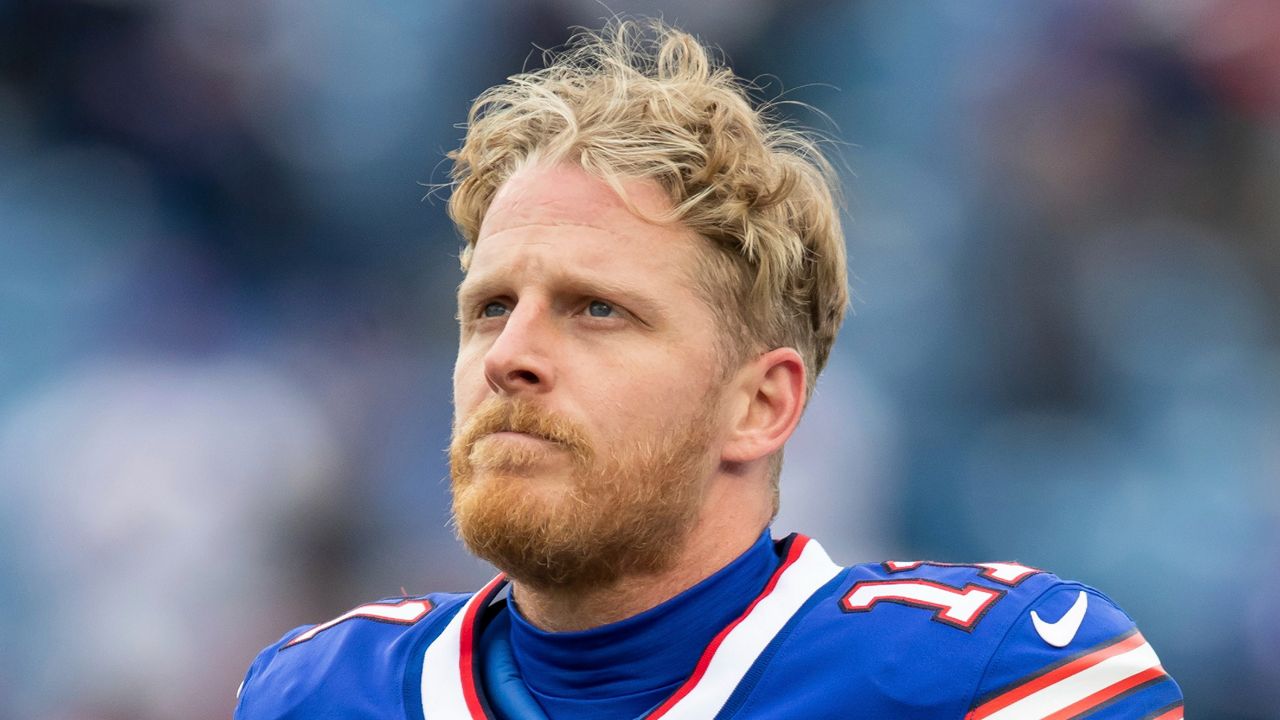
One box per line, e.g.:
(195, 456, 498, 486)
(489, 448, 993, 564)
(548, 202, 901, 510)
(236, 536, 1183, 720)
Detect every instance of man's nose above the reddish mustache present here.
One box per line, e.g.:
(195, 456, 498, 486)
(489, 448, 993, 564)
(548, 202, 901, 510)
(484, 301, 556, 395)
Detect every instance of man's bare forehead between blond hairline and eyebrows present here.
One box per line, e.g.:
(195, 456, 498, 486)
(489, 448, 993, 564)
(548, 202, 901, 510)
(463, 164, 707, 290)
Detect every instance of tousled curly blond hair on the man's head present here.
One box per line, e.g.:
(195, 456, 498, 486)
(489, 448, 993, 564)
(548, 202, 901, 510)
(448, 20, 849, 393)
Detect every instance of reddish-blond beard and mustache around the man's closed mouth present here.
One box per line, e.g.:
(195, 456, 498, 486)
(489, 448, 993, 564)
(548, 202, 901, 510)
(451, 392, 716, 588)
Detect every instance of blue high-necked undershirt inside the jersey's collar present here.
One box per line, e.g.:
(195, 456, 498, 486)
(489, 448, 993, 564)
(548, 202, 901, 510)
(480, 530, 778, 720)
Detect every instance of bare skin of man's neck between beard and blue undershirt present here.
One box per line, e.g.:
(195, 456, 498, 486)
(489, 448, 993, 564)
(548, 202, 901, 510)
(512, 489, 771, 632)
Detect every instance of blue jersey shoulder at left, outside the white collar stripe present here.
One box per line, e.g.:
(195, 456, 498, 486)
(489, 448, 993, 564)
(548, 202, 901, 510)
(234, 593, 471, 720)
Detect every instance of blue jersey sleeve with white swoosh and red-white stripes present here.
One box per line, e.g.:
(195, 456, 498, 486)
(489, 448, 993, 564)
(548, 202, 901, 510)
(965, 583, 1183, 720)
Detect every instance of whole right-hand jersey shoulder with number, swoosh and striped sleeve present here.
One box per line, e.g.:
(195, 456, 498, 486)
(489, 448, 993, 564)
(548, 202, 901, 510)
(742, 548, 1181, 720)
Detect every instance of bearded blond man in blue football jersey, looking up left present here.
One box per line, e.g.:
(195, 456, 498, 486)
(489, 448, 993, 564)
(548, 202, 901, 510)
(236, 23, 1181, 720)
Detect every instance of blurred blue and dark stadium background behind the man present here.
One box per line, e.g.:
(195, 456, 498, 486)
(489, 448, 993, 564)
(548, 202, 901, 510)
(0, 0, 1280, 720)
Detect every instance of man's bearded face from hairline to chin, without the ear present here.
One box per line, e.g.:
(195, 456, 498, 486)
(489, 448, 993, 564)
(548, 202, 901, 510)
(451, 165, 722, 585)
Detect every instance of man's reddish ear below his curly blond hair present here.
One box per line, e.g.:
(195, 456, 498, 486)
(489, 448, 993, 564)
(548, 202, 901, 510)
(721, 347, 805, 462)
